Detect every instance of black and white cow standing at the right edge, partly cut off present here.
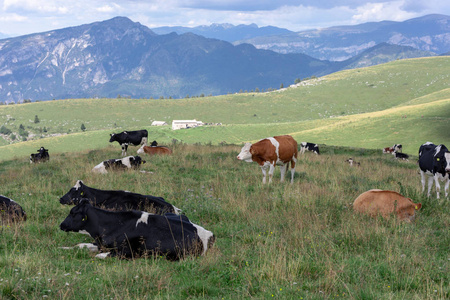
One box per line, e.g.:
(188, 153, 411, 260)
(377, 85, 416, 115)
(419, 142, 450, 199)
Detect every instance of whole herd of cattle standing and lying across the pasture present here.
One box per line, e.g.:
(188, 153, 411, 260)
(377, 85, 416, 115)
(0, 130, 450, 260)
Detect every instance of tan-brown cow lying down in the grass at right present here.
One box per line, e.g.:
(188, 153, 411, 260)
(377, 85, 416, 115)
(353, 189, 422, 222)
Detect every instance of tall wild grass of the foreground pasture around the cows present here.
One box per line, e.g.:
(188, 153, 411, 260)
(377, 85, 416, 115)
(0, 143, 450, 299)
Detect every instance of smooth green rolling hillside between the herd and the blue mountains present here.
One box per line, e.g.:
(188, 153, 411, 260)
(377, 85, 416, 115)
(0, 57, 450, 160)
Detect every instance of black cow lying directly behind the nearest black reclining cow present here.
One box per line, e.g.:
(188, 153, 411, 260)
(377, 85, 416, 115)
(59, 180, 181, 214)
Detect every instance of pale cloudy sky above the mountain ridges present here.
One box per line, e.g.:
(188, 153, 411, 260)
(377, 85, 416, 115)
(0, 0, 450, 37)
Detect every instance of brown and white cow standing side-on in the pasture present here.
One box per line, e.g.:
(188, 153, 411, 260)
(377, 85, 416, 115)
(237, 135, 298, 184)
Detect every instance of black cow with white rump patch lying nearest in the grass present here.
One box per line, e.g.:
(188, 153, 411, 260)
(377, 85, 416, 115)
(60, 200, 215, 260)
